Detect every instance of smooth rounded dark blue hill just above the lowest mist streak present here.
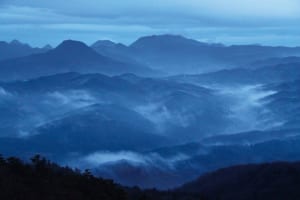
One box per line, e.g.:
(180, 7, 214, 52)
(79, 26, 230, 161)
(0, 105, 167, 160)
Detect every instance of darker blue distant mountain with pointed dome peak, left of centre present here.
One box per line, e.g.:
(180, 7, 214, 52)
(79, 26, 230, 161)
(0, 40, 153, 80)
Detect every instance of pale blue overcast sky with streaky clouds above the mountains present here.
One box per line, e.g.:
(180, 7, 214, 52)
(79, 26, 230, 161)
(0, 0, 300, 46)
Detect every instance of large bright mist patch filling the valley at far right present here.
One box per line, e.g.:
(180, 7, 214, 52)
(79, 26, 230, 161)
(214, 85, 281, 133)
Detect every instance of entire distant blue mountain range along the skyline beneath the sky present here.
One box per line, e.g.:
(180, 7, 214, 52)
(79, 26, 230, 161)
(0, 35, 300, 79)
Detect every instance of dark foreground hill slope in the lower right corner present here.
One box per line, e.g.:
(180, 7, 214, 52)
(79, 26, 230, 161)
(176, 162, 300, 200)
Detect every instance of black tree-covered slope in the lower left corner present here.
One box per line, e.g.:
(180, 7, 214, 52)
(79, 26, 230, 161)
(0, 155, 128, 200)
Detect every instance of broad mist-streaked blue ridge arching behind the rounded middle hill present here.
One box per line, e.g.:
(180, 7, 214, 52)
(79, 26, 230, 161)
(0, 73, 228, 141)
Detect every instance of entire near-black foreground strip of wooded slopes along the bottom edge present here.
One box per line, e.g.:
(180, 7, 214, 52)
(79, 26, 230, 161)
(0, 155, 300, 200)
